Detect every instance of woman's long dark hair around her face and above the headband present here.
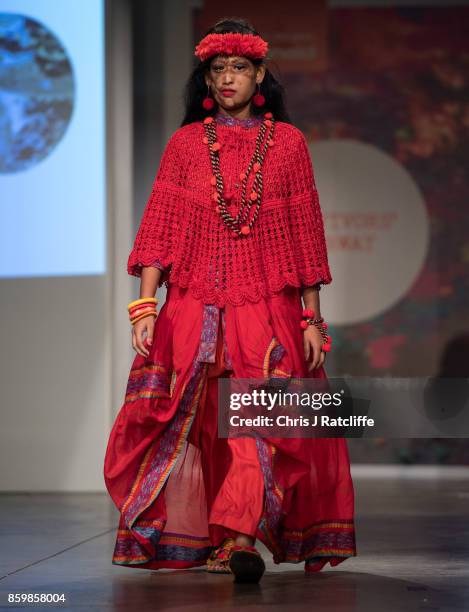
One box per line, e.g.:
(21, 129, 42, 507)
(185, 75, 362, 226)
(181, 17, 291, 127)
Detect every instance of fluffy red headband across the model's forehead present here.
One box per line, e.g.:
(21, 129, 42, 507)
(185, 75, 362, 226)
(194, 32, 269, 61)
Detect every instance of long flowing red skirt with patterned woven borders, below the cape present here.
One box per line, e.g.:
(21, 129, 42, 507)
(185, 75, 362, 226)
(104, 285, 356, 570)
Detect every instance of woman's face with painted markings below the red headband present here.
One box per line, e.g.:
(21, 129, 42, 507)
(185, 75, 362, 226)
(205, 55, 265, 110)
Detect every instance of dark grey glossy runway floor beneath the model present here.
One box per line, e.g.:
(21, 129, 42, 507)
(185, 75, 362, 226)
(0, 478, 469, 612)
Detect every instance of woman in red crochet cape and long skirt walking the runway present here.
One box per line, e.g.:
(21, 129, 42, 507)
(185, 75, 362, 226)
(104, 19, 356, 582)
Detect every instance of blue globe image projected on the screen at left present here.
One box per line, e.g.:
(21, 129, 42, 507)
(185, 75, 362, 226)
(0, 13, 75, 174)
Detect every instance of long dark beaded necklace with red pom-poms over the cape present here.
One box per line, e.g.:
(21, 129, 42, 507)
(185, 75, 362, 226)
(203, 113, 275, 237)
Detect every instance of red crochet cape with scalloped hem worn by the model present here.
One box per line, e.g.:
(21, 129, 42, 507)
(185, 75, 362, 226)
(127, 121, 332, 307)
